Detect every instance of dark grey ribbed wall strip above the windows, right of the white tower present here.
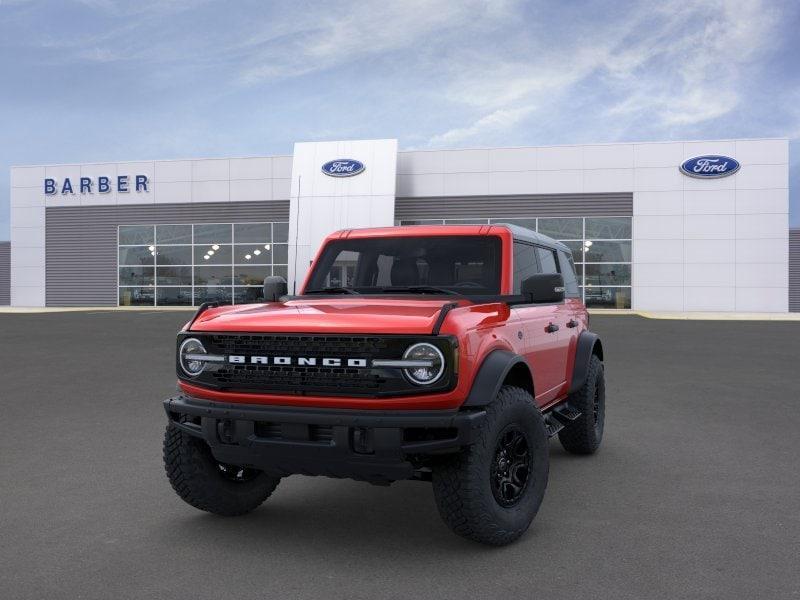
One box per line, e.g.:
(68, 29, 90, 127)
(394, 194, 633, 220)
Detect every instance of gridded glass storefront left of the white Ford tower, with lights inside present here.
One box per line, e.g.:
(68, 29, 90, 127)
(118, 222, 289, 306)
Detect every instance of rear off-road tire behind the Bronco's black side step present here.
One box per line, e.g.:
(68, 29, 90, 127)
(558, 354, 606, 454)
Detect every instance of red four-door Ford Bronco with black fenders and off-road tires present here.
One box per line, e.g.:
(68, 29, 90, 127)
(164, 225, 605, 545)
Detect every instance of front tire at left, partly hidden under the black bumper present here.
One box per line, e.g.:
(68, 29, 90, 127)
(164, 424, 280, 516)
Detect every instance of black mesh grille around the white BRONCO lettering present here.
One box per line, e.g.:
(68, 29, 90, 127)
(178, 333, 452, 397)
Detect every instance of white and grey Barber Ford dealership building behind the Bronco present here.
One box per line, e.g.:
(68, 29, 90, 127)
(0, 139, 800, 313)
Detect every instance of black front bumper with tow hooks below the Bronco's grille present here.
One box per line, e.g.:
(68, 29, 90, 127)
(164, 395, 486, 483)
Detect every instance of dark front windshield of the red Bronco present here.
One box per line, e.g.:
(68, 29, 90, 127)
(305, 235, 501, 295)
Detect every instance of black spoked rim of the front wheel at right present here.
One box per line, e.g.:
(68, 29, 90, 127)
(491, 424, 531, 508)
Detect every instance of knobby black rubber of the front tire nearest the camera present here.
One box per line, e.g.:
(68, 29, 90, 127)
(433, 385, 550, 546)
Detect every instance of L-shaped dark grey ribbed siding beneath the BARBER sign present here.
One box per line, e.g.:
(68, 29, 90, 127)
(45, 200, 289, 306)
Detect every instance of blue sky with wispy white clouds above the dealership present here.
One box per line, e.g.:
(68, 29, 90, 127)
(0, 0, 800, 239)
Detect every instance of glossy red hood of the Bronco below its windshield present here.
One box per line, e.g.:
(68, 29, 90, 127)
(190, 297, 463, 334)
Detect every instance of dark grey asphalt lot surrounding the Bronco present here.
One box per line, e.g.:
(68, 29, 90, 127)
(0, 312, 800, 600)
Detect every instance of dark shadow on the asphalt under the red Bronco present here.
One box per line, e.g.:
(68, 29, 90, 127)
(156, 445, 580, 559)
